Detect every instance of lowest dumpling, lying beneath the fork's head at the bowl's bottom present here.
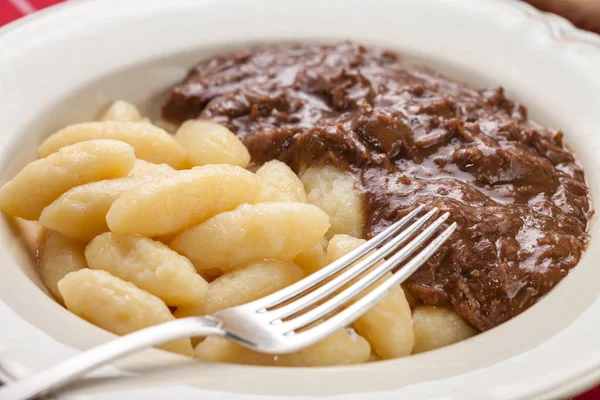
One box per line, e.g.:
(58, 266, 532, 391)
(194, 329, 371, 367)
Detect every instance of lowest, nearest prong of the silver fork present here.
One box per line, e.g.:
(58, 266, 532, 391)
(290, 222, 457, 352)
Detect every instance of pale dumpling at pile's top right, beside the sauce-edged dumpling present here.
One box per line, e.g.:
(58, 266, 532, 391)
(256, 160, 306, 203)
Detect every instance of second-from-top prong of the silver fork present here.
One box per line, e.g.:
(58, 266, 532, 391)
(267, 208, 438, 320)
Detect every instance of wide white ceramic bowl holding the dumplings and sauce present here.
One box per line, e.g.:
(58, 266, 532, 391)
(0, 0, 600, 400)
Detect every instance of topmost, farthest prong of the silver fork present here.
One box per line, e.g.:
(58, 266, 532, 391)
(244, 206, 425, 311)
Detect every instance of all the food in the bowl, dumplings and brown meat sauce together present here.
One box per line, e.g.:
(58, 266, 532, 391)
(0, 42, 593, 366)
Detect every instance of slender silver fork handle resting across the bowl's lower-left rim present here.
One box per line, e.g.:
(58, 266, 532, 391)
(0, 317, 224, 400)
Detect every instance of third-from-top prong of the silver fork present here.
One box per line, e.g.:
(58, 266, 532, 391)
(276, 213, 450, 334)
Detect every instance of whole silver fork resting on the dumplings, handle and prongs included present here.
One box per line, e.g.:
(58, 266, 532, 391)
(0, 206, 456, 400)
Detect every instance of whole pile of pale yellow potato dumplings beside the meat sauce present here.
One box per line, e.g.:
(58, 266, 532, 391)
(0, 101, 475, 366)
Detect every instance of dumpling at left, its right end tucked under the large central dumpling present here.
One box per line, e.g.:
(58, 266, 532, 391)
(40, 176, 153, 241)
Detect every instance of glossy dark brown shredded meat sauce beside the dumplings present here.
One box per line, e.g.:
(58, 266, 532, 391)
(163, 43, 592, 331)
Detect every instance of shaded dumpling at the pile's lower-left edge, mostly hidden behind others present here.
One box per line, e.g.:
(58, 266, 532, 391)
(38, 229, 87, 303)
